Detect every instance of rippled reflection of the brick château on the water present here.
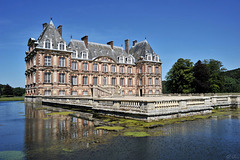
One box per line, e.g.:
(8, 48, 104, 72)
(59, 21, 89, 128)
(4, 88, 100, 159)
(25, 103, 108, 158)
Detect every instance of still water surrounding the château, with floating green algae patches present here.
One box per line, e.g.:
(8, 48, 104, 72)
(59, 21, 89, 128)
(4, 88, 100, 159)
(0, 102, 240, 159)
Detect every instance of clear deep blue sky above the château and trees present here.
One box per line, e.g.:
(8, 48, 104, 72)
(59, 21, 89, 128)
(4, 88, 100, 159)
(0, 0, 240, 87)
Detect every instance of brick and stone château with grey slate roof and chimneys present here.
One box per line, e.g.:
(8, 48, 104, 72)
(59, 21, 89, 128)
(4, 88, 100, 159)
(25, 20, 162, 97)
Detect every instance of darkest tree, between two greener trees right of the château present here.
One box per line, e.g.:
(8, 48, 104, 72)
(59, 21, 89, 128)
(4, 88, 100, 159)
(192, 60, 210, 93)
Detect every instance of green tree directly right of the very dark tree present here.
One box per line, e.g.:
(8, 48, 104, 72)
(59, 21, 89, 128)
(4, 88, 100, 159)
(204, 59, 225, 93)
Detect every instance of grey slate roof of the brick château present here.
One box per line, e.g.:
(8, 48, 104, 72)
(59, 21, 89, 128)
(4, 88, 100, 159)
(28, 20, 158, 62)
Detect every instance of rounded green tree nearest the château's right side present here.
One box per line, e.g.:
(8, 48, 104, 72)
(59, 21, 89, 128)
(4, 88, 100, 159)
(166, 58, 194, 93)
